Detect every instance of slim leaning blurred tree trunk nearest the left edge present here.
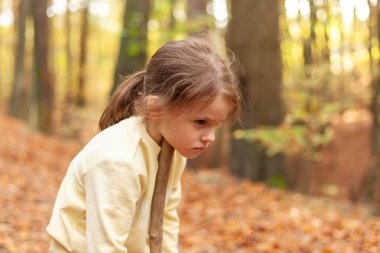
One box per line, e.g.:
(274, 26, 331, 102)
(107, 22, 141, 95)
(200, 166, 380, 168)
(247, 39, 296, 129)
(8, 0, 30, 118)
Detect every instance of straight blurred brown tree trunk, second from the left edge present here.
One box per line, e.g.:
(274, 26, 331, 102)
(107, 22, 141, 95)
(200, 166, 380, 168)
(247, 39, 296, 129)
(33, 0, 54, 133)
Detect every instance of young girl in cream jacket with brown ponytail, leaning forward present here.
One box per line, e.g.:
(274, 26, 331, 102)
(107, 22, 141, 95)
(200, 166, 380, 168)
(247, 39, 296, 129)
(47, 38, 240, 253)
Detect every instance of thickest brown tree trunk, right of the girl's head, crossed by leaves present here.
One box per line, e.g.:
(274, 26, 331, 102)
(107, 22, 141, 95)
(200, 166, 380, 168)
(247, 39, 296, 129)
(227, 0, 284, 180)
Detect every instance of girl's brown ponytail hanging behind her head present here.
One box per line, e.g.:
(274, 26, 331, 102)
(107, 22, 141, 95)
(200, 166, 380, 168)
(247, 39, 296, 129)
(99, 70, 146, 130)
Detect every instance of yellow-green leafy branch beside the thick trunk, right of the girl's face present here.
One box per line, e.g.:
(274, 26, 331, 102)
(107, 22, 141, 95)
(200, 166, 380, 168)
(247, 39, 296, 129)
(234, 65, 341, 161)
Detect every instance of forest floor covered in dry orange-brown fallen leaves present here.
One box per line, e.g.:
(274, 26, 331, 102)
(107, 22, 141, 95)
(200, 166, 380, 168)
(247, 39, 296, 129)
(0, 111, 380, 253)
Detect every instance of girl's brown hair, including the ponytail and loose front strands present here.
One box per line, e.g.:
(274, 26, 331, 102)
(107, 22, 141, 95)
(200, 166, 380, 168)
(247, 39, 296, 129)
(99, 38, 241, 129)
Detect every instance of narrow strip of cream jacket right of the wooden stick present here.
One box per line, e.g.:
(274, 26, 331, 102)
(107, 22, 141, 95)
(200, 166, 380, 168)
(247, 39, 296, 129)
(162, 156, 186, 253)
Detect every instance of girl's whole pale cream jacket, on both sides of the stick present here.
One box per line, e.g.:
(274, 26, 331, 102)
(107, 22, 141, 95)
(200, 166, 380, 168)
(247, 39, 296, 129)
(46, 117, 186, 253)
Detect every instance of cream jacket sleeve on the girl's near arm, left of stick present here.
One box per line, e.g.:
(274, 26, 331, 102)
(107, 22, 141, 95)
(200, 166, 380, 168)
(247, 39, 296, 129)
(84, 160, 145, 253)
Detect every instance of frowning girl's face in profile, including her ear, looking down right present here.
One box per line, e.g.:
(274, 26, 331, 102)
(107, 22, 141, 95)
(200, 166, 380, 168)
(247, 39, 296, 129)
(147, 94, 231, 159)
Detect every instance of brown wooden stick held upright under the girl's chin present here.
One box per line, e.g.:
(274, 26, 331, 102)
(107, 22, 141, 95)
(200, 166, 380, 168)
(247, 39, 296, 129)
(149, 139, 174, 253)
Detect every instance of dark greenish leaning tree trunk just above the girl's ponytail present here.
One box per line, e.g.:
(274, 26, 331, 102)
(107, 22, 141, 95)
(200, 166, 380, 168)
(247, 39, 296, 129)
(111, 0, 150, 94)
